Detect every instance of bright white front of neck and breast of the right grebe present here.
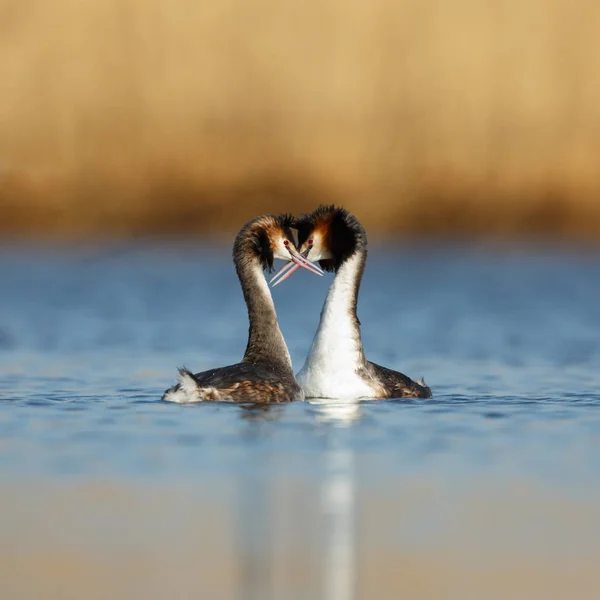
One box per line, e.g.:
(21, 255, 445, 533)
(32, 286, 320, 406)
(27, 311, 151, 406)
(296, 254, 373, 398)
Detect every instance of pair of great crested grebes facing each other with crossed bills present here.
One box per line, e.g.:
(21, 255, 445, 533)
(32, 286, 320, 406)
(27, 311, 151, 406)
(163, 206, 431, 403)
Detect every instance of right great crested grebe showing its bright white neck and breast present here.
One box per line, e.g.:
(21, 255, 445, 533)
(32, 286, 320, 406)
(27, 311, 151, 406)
(271, 206, 431, 399)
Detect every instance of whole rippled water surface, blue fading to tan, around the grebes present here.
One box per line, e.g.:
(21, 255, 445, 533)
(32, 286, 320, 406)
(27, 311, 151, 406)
(0, 242, 600, 600)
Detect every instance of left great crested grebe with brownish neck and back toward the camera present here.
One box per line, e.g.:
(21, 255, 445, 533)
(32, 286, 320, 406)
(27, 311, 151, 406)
(162, 215, 323, 404)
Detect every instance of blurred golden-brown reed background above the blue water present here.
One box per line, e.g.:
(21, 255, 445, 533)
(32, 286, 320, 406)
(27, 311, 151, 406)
(0, 0, 600, 239)
